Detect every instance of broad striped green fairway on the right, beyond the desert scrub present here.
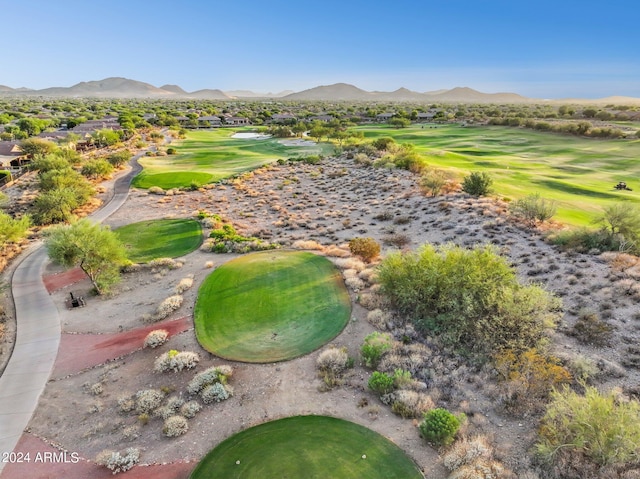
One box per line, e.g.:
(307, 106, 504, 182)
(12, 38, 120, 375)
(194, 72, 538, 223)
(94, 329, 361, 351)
(357, 125, 640, 225)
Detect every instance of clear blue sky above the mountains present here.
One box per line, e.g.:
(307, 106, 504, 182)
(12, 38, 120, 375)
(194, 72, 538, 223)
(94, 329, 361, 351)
(0, 0, 640, 98)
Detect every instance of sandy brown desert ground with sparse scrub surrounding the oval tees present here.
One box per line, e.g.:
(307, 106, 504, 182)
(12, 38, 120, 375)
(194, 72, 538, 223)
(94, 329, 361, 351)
(2, 159, 640, 479)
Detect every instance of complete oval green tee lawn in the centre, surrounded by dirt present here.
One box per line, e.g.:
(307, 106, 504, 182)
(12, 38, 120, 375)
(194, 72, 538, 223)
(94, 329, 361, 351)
(194, 251, 351, 363)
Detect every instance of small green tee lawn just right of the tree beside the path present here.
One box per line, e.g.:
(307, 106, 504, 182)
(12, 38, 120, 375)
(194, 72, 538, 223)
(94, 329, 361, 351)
(114, 219, 202, 263)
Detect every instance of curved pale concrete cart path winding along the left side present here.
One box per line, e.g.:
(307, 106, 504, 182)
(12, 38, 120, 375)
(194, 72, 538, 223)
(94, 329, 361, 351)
(0, 155, 142, 472)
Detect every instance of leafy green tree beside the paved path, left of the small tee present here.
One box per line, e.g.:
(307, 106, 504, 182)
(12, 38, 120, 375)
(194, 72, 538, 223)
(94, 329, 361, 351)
(46, 219, 127, 294)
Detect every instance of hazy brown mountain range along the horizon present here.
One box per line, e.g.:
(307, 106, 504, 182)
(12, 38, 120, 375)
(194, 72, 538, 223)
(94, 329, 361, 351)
(0, 77, 640, 104)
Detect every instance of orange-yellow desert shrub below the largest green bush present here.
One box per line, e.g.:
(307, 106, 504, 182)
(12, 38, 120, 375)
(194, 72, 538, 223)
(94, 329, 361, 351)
(493, 349, 571, 413)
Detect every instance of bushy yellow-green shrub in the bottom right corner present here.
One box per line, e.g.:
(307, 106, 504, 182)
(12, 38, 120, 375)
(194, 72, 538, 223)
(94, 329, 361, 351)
(536, 386, 640, 477)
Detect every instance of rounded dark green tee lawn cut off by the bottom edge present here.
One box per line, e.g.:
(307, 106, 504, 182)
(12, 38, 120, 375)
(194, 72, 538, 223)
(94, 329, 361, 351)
(190, 416, 424, 479)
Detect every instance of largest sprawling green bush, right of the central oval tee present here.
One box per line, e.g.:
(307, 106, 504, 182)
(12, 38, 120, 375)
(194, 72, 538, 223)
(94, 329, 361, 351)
(378, 244, 560, 356)
